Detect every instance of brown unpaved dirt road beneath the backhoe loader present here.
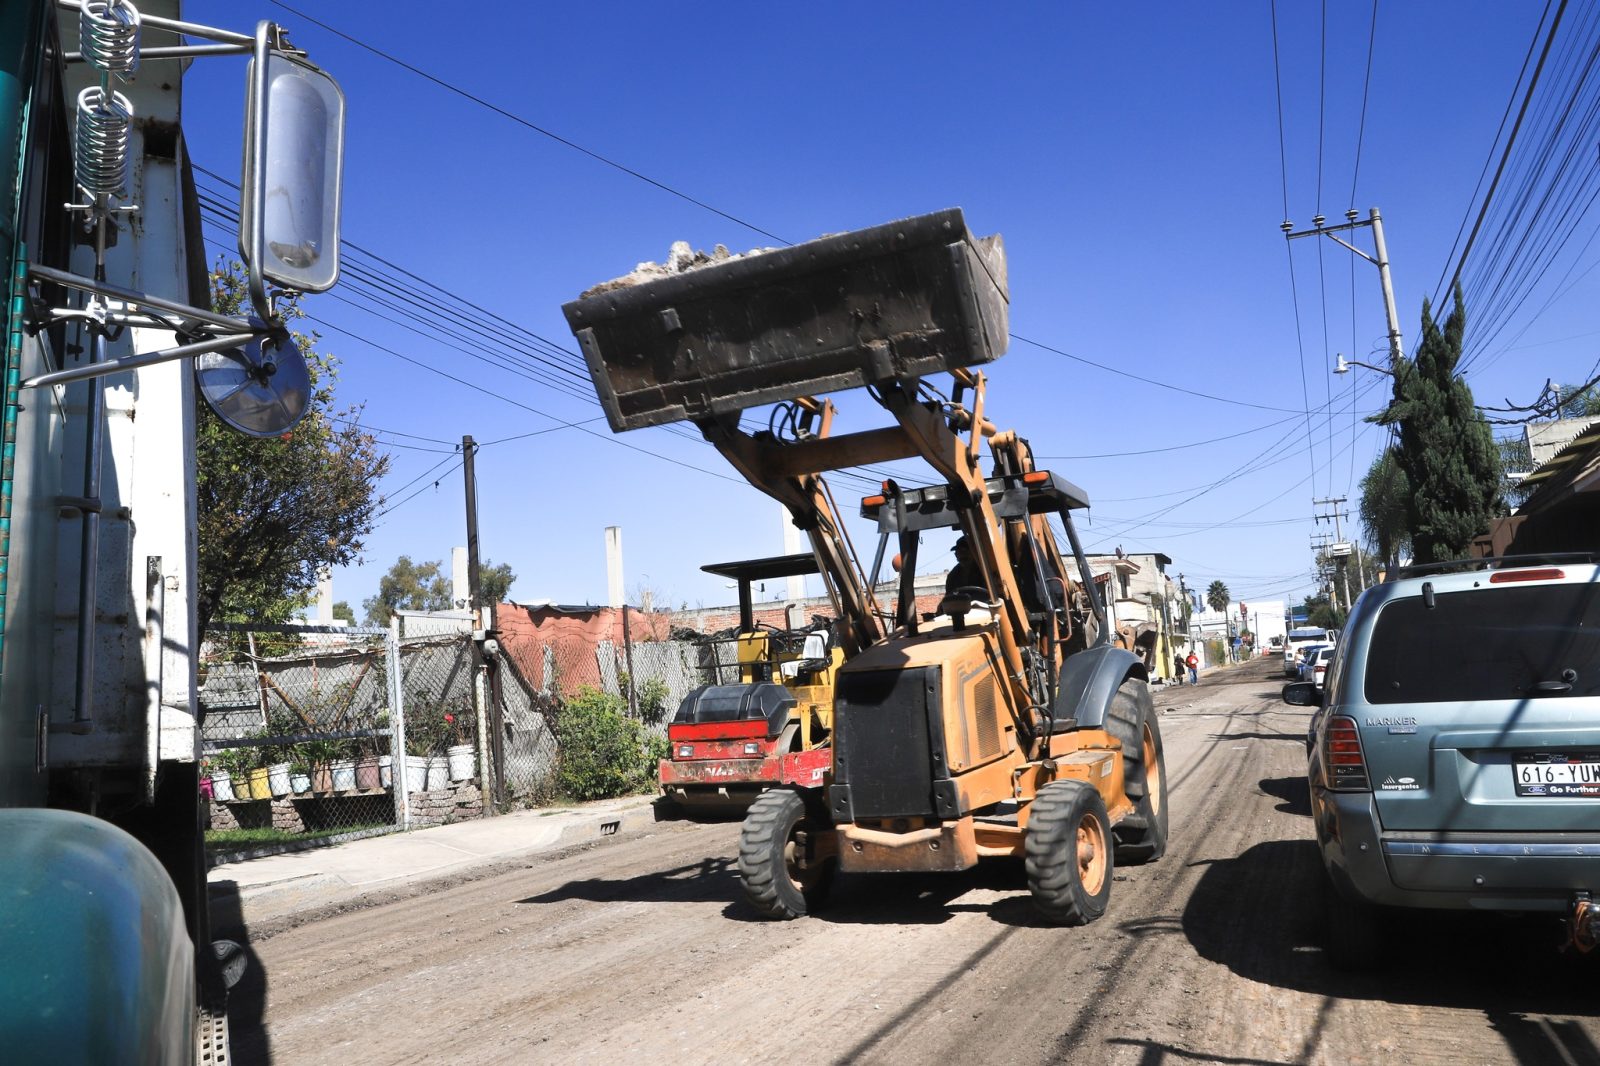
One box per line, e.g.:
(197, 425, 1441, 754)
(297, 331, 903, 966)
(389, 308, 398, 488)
(234, 663, 1600, 1066)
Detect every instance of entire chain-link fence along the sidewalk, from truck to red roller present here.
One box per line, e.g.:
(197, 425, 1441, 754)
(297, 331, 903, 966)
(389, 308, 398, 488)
(200, 611, 758, 852)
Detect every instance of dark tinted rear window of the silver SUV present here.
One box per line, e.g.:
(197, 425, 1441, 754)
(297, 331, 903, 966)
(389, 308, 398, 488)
(1365, 584, 1600, 703)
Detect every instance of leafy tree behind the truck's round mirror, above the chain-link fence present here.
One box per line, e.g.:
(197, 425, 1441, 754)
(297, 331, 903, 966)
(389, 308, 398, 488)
(195, 264, 389, 629)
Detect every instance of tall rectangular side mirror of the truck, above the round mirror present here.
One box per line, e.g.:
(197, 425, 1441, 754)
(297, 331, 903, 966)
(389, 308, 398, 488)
(238, 22, 344, 302)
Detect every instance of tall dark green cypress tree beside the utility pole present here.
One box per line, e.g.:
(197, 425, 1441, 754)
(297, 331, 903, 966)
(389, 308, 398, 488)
(1371, 282, 1501, 563)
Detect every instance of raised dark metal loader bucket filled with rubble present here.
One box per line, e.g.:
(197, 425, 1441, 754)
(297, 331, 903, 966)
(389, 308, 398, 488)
(562, 208, 1008, 432)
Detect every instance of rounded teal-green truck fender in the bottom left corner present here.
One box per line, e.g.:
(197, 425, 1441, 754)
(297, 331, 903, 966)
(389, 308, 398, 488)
(0, 808, 195, 1066)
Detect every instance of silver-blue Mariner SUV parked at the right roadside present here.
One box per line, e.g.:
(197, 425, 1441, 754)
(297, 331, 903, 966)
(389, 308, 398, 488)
(1283, 555, 1600, 967)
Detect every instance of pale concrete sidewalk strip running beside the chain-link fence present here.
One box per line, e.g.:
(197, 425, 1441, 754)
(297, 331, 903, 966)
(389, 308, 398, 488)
(208, 795, 672, 924)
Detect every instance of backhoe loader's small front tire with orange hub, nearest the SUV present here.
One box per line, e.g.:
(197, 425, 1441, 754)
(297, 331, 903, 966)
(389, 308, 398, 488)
(1022, 781, 1115, 925)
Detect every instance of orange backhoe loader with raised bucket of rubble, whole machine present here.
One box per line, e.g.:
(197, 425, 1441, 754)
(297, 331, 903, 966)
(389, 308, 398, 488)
(563, 210, 1168, 925)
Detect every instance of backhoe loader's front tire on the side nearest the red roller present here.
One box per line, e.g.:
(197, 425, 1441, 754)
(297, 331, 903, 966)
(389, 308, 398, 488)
(739, 789, 835, 919)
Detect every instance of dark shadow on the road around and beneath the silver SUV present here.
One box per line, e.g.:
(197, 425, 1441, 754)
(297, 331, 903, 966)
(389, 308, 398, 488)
(1182, 832, 1600, 1043)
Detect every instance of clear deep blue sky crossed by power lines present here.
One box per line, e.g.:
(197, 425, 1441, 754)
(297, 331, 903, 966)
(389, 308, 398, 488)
(186, 0, 1600, 605)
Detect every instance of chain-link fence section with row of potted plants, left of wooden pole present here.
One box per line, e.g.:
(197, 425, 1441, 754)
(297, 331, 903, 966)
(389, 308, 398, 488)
(198, 626, 496, 850)
